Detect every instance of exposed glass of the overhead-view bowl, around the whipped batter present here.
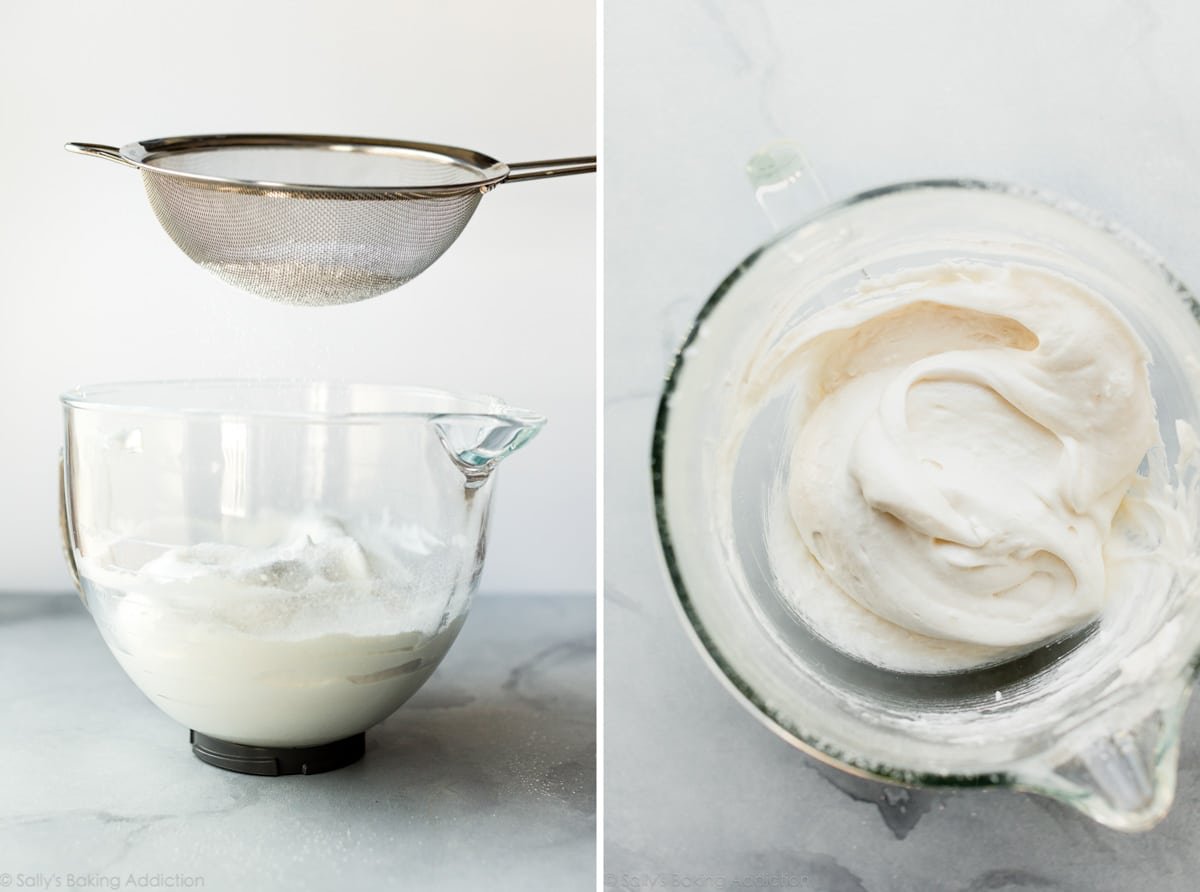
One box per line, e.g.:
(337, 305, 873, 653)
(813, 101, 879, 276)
(653, 180, 1200, 830)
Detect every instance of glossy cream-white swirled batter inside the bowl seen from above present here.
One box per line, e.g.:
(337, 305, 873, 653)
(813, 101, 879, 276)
(743, 262, 1159, 671)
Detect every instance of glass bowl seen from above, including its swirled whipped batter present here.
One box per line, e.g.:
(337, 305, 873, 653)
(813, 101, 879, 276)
(654, 181, 1200, 828)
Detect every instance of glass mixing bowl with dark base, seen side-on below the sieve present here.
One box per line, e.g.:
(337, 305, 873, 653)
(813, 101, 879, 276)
(61, 381, 545, 774)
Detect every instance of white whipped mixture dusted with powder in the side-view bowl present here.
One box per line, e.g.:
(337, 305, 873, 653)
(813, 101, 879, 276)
(78, 513, 470, 747)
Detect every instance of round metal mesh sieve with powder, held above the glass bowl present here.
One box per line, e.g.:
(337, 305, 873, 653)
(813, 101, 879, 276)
(67, 134, 595, 306)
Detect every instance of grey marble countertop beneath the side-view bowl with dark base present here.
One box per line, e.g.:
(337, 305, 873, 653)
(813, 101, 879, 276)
(0, 594, 595, 892)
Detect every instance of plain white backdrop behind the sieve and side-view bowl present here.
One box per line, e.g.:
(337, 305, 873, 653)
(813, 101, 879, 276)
(0, 0, 596, 600)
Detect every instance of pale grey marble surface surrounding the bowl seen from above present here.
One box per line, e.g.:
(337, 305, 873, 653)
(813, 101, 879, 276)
(604, 0, 1200, 892)
